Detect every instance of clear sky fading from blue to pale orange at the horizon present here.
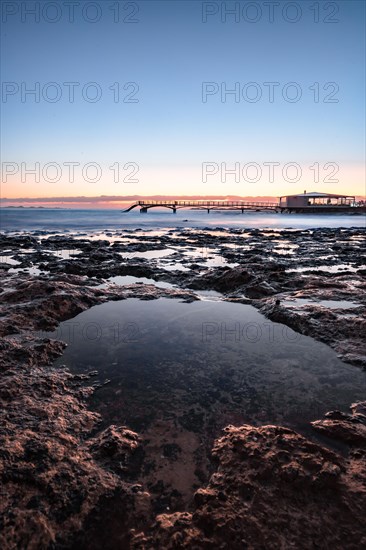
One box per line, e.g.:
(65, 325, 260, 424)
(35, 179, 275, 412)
(1, 0, 365, 205)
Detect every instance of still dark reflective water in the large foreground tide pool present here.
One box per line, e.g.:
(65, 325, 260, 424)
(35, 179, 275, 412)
(51, 298, 366, 437)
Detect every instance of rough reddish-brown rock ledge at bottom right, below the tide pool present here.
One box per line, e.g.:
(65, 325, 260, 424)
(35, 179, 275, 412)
(132, 412, 366, 550)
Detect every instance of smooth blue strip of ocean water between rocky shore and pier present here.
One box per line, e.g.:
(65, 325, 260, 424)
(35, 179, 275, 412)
(0, 208, 366, 232)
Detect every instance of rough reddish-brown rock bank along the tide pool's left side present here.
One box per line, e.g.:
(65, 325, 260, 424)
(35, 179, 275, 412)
(0, 277, 197, 550)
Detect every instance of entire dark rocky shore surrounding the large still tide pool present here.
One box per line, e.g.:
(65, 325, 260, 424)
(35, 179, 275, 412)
(0, 229, 366, 549)
